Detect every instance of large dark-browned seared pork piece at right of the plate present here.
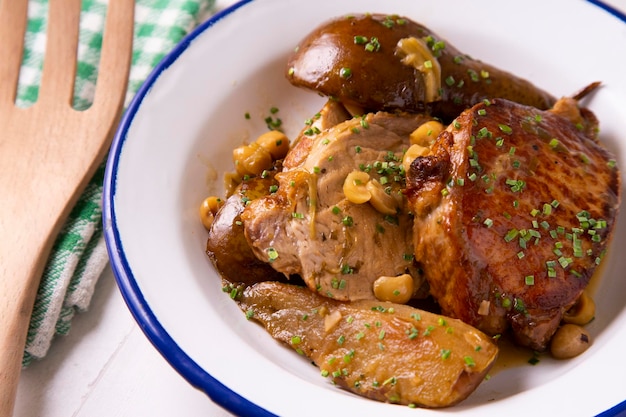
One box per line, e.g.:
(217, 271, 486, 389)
(407, 99, 621, 350)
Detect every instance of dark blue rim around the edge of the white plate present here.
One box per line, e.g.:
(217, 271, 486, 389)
(103, 0, 626, 417)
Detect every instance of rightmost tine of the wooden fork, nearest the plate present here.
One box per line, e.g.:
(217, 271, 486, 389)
(92, 0, 135, 111)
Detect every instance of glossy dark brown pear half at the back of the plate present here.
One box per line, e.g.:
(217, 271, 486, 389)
(286, 14, 555, 121)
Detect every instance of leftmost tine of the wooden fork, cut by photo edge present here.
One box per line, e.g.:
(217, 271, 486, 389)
(0, 0, 28, 104)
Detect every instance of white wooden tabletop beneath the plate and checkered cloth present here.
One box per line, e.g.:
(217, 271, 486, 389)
(15, 0, 626, 417)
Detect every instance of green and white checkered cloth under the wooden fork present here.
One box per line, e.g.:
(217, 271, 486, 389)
(20, 0, 214, 366)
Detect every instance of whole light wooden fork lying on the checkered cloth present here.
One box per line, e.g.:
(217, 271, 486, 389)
(0, 0, 135, 417)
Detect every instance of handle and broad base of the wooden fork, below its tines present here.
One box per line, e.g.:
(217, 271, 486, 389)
(0, 105, 92, 417)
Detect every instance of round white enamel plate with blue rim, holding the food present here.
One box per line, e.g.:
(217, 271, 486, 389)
(104, 0, 626, 417)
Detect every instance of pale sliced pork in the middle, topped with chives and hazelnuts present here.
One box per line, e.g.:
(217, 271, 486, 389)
(241, 113, 428, 300)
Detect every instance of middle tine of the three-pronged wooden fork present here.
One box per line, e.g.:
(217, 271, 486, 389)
(39, 0, 81, 105)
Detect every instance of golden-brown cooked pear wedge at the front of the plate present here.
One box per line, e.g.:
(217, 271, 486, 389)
(239, 282, 498, 408)
